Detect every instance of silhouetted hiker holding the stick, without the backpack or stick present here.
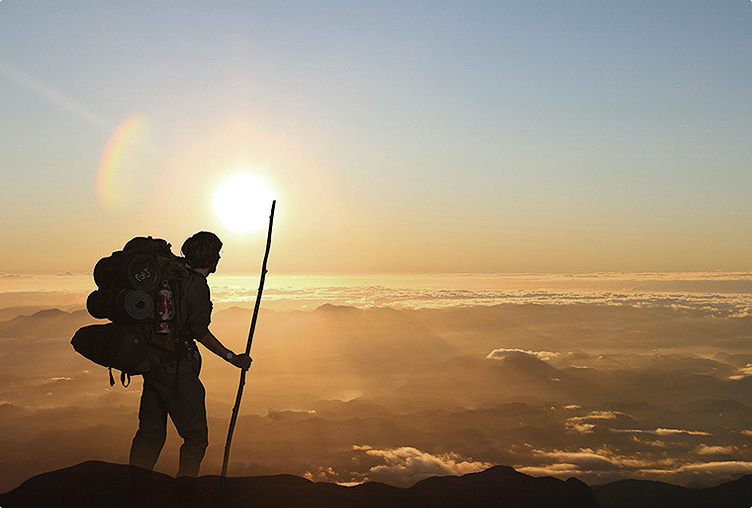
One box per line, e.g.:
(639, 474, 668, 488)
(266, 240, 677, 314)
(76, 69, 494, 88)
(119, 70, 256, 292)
(129, 231, 252, 481)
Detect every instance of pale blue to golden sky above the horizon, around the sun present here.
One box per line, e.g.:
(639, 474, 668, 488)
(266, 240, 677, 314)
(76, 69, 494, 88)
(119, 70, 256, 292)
(0, 0, 752, 274)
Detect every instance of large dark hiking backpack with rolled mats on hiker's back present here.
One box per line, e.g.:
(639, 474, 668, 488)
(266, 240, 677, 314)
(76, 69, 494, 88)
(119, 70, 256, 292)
(71, 237, 192, 386)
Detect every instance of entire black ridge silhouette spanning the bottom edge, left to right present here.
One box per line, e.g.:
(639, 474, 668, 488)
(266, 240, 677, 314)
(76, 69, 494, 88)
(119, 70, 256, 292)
(0, 461, 752, 508)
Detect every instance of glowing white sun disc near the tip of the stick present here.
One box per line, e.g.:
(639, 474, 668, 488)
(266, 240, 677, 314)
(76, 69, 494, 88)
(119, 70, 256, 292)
(213, 172, 274, 234)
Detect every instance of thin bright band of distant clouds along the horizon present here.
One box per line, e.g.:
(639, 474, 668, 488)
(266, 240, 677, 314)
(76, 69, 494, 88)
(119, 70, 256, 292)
(0, 272, 752, 318)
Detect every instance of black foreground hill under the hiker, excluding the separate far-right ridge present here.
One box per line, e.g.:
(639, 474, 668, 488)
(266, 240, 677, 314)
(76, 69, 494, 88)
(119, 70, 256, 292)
(0, 461, 601, 508)
